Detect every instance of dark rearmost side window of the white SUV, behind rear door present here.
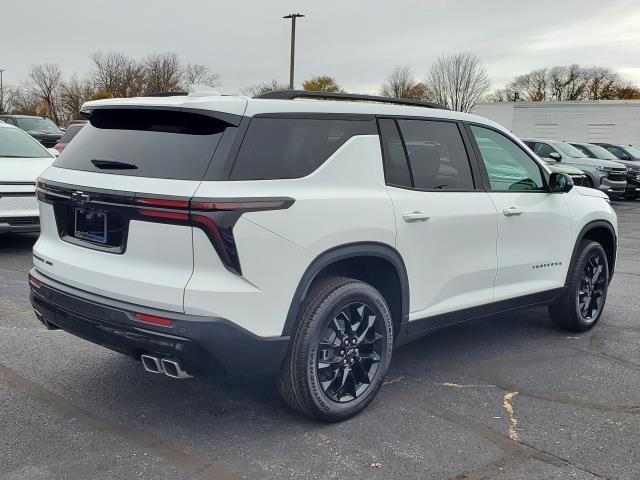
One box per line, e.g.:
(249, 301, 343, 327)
(231, 117, 377, 180)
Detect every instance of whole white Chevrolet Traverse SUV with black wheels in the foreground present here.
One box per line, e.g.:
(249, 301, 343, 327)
(30, 91, 617, 421)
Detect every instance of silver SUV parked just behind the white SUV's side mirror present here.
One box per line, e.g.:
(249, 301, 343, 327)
(523, 138, 627, 198)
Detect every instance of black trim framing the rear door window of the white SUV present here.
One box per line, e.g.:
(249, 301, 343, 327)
(376, 115, 485, 193)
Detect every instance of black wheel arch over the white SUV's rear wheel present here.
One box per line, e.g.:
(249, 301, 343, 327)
(282, 242, 409, 336)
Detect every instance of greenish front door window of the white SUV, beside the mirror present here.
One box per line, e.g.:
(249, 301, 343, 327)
(471, 125, 545, 191)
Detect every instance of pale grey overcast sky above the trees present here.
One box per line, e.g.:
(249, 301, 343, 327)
(0, 0, 640, 93)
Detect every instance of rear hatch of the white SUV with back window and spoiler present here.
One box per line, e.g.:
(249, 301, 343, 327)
(34, 97, 246, 311)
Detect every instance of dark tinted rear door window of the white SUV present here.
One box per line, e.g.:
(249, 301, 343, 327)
(380, 119, 474, 190)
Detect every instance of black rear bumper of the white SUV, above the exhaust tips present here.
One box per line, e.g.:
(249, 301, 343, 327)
(30, 268, 289, 374)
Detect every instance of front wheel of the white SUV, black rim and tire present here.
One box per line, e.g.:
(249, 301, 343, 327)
(549, 240, 609, 332)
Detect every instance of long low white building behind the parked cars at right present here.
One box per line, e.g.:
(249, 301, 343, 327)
(474, 100, 640, 146)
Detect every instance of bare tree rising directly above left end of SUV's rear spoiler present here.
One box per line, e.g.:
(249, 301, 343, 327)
(90, 52, 144, 97)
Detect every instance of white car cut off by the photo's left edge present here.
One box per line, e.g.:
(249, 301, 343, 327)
(0, 123, 56, 235)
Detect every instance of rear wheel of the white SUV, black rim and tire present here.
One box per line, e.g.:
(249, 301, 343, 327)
(278, 277, 393, 422)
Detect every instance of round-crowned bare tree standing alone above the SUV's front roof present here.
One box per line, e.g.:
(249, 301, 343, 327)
(425, 53, 489, 112)
